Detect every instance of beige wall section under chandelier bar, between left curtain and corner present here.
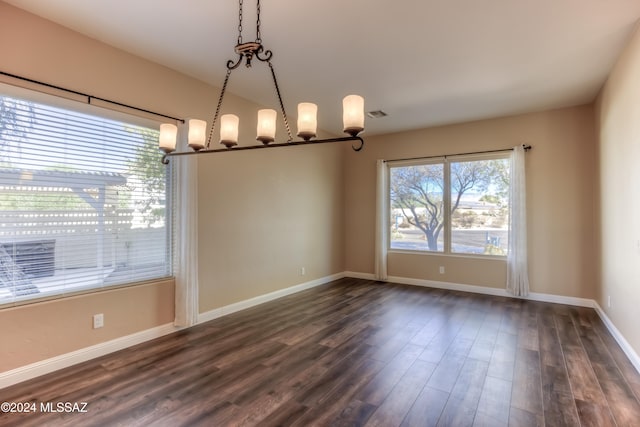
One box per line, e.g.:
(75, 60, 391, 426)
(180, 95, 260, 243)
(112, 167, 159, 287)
(198, 145, 344, 311)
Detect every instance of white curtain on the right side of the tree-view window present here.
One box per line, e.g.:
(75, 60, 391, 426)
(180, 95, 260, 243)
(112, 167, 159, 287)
(507, 145, 529, 296)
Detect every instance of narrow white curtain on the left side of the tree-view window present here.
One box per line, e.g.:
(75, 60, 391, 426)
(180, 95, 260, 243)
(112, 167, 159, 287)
(375, 160, 389, 281)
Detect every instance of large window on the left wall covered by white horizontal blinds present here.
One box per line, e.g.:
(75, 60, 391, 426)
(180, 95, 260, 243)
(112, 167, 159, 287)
(0, 86, 172, 304)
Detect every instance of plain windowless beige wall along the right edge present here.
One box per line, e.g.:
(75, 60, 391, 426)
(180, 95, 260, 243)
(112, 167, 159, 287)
(597, 23, 640, 353)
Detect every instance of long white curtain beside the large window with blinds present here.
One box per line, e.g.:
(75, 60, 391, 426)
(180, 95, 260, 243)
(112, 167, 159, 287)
(171, 125, 198, 327)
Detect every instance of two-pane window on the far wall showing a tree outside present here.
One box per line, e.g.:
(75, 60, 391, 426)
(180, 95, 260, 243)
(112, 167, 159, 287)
(389, 155, 509, 256)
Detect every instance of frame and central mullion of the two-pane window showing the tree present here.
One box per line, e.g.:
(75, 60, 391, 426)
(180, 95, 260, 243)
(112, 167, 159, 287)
(385, 151, 511, 260)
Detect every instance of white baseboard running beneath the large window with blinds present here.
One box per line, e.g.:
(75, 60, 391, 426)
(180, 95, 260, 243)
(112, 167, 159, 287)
(0, 323, 179, 389)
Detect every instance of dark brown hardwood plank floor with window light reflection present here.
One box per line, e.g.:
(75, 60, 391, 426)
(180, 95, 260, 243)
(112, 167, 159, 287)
(0, 279, 640, 427)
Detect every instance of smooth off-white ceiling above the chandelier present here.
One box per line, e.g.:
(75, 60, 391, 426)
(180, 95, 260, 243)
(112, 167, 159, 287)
(5, 0, 640, 135)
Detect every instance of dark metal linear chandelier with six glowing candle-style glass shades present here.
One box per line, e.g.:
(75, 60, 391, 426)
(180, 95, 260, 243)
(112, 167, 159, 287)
(159, 0, 364, 164)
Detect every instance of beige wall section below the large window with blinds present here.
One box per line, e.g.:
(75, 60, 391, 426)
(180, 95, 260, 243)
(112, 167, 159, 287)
(0, 280, 173, 372)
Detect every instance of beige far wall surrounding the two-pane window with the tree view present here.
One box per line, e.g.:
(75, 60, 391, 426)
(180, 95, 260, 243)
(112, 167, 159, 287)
(345, 106, 597, 298)
